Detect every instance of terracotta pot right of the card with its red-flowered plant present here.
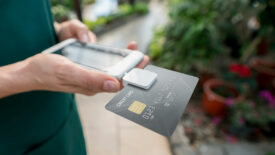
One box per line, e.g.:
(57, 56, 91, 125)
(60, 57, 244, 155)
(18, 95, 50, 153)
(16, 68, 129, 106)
(202, 63, 256, 116)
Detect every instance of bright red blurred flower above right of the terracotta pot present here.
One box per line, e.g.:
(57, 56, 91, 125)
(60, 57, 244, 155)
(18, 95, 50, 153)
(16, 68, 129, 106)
(229, 64, 251, 77)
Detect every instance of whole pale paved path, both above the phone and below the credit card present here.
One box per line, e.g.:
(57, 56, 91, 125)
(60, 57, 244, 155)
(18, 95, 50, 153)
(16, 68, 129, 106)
(76, 1, 171, 155)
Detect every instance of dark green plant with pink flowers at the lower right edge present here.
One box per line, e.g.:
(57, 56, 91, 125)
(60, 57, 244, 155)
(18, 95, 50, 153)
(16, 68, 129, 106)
(226, 90, 275, 138)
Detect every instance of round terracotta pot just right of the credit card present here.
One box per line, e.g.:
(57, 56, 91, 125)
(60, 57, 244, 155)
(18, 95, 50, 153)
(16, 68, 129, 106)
(202, 79, 240, 116)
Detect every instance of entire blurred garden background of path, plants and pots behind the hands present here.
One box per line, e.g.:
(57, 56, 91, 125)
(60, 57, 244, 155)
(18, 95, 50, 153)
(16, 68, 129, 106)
(51, 0, 275, 155)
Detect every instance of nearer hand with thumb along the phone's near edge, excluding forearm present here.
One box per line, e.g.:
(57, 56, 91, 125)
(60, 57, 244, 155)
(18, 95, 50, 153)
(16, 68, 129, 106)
(24, 54, 120, 95)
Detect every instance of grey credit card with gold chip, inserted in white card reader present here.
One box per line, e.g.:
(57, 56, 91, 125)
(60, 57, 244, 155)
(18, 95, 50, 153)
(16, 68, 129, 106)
(105, 65, 199, 137)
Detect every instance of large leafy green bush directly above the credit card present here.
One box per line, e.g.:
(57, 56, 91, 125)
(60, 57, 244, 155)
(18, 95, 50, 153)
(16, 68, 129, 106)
(151, 0, 223, 73)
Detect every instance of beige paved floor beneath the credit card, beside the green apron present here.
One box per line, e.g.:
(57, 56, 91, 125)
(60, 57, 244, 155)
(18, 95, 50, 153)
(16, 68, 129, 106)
(76, 93, 171, 155)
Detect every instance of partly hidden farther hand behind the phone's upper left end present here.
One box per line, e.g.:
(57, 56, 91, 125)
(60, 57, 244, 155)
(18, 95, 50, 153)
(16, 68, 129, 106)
(54, 20, 97, 43)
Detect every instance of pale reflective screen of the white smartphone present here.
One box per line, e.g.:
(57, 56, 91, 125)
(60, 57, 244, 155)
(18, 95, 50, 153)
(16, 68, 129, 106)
(54, 43, 127, 71)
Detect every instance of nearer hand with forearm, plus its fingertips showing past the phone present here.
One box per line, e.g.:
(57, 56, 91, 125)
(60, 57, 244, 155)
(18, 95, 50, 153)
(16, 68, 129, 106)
(0, 42, 149, 98)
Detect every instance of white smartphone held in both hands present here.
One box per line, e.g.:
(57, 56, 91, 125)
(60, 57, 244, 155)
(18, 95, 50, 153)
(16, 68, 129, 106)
(42, 39, 144, 79)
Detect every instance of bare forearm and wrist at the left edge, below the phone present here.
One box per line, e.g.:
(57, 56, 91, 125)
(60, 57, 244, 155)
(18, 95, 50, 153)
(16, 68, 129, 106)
(0, 60, 35, 99)
